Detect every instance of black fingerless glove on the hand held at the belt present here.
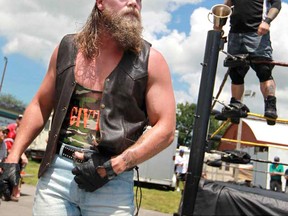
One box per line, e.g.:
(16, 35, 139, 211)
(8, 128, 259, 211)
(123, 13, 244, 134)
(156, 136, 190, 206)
(72, 153, 110, 192)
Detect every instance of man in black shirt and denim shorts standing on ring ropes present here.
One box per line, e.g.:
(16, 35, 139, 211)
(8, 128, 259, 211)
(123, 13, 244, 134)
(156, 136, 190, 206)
(224, 0, 281, 125)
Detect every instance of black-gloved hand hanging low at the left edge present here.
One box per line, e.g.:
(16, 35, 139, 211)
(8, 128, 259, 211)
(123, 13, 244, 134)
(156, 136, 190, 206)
(0, 163, 21, 187)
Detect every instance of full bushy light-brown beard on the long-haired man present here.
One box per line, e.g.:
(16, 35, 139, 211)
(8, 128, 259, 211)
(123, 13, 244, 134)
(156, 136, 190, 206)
(101, 9, 143, 53)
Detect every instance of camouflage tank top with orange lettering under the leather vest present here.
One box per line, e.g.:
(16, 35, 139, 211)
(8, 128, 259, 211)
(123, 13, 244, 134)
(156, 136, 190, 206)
(59, 84, 102, 149)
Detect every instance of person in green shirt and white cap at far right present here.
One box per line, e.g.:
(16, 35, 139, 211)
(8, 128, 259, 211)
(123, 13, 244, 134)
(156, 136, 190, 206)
(269, 156, 284, 192)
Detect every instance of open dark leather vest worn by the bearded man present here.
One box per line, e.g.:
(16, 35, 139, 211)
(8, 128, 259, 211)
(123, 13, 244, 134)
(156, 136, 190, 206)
(38, 34, 150, 177)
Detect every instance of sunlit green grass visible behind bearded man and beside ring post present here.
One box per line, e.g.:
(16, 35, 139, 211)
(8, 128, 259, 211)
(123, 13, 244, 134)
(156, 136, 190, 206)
(24, 160, 181, 214)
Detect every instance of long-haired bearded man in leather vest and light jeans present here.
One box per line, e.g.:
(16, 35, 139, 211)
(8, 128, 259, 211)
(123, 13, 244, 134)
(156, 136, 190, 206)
(0, 0, 176, 216)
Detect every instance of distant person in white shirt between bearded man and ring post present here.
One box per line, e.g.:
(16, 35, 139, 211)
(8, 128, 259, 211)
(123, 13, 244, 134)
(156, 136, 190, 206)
(175, 149, 188, 191)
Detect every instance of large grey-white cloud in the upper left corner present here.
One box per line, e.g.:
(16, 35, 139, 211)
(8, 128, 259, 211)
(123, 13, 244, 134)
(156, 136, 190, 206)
(0, 0, 94, 65)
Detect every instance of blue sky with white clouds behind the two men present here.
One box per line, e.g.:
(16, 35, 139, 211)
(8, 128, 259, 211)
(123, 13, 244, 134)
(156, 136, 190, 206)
(0, 0, 288, 117)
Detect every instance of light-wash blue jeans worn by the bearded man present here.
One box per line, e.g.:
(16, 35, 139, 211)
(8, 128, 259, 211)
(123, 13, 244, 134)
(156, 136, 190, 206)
(33, 155, 134, 216)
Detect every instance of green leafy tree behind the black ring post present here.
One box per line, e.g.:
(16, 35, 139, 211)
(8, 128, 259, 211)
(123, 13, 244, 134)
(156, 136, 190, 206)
(176, 102, 224, 148)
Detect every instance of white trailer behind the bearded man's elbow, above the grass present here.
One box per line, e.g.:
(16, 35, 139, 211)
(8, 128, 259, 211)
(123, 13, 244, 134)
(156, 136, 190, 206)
(134, 130, 178, 190)
